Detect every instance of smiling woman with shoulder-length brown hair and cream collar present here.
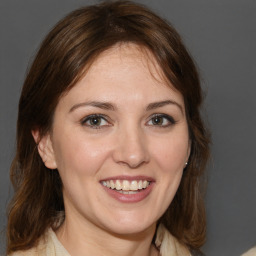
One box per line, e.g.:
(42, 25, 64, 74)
(7, 1, 209, 256)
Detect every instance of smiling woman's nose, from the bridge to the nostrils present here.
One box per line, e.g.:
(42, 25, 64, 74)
(113, 125, 149, 169)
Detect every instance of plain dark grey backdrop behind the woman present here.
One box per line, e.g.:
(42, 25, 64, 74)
(0, 0, 256, 256)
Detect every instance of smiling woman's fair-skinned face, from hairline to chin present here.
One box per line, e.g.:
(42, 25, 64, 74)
(44, 44, 190, 234)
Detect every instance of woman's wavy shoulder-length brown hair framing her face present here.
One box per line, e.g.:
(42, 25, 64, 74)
(7, 1, 209, 253)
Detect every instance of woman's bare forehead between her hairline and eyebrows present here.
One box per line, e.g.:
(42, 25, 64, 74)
(57, 43, 183, 109)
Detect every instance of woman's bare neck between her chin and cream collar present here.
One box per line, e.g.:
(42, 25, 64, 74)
(56, 214, 158, 256)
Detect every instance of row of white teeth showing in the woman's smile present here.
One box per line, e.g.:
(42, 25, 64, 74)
(101, 180, 150, 191)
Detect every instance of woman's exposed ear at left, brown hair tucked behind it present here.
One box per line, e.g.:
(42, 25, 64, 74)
(31, 129, 57, 169)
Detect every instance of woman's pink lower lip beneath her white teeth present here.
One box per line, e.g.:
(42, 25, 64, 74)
(102, 182, 153, 203)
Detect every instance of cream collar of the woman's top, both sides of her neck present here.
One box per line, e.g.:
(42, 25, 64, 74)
(8, 225, 190, 256)
